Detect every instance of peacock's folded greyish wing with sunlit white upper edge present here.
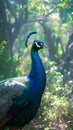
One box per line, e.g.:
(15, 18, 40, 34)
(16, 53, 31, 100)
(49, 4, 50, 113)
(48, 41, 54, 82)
(0, 78, 30, 120)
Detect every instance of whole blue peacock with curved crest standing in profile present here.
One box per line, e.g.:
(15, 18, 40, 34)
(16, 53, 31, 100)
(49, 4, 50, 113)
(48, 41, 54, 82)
(0, 32, 47, 130)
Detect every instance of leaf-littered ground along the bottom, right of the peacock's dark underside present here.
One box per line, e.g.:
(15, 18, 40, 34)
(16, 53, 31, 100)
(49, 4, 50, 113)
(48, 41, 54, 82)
(22, 115, 68, 130)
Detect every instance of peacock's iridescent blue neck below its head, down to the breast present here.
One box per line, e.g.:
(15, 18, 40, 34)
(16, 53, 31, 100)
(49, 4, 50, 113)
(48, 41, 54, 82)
(29, 49, 46, 103)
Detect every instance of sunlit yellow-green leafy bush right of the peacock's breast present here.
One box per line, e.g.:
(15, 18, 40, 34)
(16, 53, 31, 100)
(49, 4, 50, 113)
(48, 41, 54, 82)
(40, 62, 73, 128)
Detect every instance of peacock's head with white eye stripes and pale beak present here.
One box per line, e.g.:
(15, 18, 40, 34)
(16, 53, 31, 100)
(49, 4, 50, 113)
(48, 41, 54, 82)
(32, 40, 47, 51)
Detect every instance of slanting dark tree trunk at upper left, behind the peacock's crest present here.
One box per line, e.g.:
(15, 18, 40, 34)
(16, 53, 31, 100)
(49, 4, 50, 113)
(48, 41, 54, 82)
(7, 0, 28, 52)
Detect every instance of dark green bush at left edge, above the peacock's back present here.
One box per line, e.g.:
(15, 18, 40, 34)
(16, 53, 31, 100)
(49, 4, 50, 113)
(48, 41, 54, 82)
(0, 41, 18, 80)
